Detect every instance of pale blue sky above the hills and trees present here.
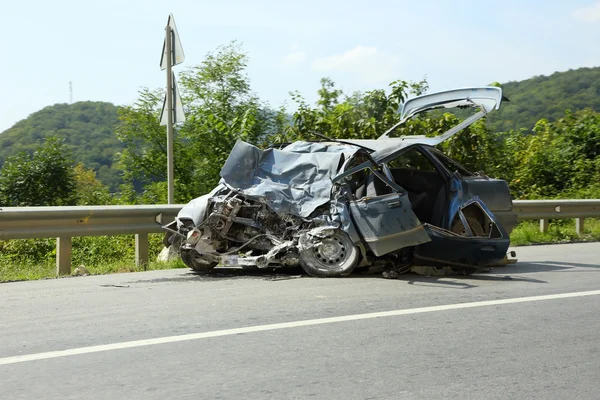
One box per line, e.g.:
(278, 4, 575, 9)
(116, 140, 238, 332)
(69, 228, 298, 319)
(0, 0, 600, 132)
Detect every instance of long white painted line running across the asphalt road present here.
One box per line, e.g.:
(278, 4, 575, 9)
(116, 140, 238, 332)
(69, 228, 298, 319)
(0, 290, 600, 365)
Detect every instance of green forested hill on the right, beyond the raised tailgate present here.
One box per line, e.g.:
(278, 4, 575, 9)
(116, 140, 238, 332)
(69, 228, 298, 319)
(490, 67, 600, 131)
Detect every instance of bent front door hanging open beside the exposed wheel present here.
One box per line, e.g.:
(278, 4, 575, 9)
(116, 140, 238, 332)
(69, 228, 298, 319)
(334, 164, 431, 256)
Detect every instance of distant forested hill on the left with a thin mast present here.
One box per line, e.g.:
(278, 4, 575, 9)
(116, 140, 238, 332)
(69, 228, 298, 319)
(0, 101, 123, 191)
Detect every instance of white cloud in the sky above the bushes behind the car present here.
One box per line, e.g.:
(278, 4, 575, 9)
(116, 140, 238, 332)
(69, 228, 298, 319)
(311, 45, 400, 84)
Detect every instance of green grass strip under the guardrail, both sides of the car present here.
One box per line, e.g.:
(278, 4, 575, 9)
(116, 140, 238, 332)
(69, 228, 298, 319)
(0, 218, 600, 282)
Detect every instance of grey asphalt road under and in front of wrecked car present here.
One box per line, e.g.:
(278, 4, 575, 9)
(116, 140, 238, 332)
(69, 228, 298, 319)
(0, 243, 600, 399)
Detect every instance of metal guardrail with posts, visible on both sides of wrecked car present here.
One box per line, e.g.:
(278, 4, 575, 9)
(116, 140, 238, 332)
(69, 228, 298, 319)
(0, 199, 600, 275)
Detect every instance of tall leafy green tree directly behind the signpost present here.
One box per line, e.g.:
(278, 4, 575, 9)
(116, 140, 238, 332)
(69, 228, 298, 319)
(117, 42, 285, 202)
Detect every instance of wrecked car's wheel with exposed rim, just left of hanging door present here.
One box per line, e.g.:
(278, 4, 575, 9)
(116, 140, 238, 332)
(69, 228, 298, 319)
(299, 230, 360, 278)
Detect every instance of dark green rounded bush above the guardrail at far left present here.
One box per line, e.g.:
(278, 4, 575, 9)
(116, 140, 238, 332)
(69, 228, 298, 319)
(0, 138, 76, 207)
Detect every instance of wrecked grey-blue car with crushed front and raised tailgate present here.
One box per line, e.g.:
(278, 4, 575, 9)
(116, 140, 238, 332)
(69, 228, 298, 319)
(164, 87, 516, 277)
